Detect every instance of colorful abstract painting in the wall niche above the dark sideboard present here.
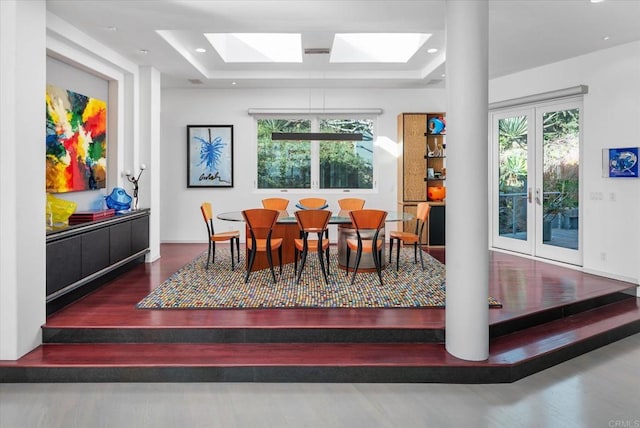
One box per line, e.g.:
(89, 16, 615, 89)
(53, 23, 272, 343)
(46, 85, 107, 193)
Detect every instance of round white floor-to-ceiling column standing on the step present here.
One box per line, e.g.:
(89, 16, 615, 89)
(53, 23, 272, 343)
(446, 0, 489, 361)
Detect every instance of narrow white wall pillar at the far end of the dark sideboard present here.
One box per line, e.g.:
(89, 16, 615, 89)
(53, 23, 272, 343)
(139, 67, 161, 262)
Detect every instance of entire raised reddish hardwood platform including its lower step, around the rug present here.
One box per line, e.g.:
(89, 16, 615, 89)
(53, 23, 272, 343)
(0, 244, 640, 383)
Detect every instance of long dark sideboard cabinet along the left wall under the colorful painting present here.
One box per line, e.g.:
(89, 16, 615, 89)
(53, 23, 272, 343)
(47, 209, 150, 314)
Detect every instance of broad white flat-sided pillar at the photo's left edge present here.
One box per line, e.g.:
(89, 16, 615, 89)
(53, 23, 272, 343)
(0, 0, 46, 360)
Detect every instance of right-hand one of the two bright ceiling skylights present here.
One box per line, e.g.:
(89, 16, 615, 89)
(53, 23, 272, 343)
(330, 33, 431, 63)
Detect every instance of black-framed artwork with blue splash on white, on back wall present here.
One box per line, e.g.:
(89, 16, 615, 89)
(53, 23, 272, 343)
(187, 125, 233, 187)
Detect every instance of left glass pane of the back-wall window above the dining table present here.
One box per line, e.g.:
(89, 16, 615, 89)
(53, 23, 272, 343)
(258, 119, 311, 189)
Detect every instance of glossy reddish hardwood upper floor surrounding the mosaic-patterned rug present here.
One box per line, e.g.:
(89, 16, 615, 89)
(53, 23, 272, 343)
(46, 244, 635, 328)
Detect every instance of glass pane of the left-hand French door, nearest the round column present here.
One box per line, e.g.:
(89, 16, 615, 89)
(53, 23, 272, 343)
(498, 116, 528, 241)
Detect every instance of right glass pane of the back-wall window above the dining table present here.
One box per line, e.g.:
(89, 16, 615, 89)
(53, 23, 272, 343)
(320, 119, 373, 189)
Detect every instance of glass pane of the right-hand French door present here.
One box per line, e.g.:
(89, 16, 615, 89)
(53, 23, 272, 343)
(542, 108, 580, 250)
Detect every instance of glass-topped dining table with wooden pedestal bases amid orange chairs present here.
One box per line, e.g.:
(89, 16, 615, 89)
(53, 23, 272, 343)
(216, 210, 415, 271)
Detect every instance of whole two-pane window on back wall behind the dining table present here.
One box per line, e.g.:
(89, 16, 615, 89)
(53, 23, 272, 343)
(257, 118, 374, 189)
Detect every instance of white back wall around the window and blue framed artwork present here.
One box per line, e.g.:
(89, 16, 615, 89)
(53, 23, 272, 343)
(160, 88, 446, 242)
